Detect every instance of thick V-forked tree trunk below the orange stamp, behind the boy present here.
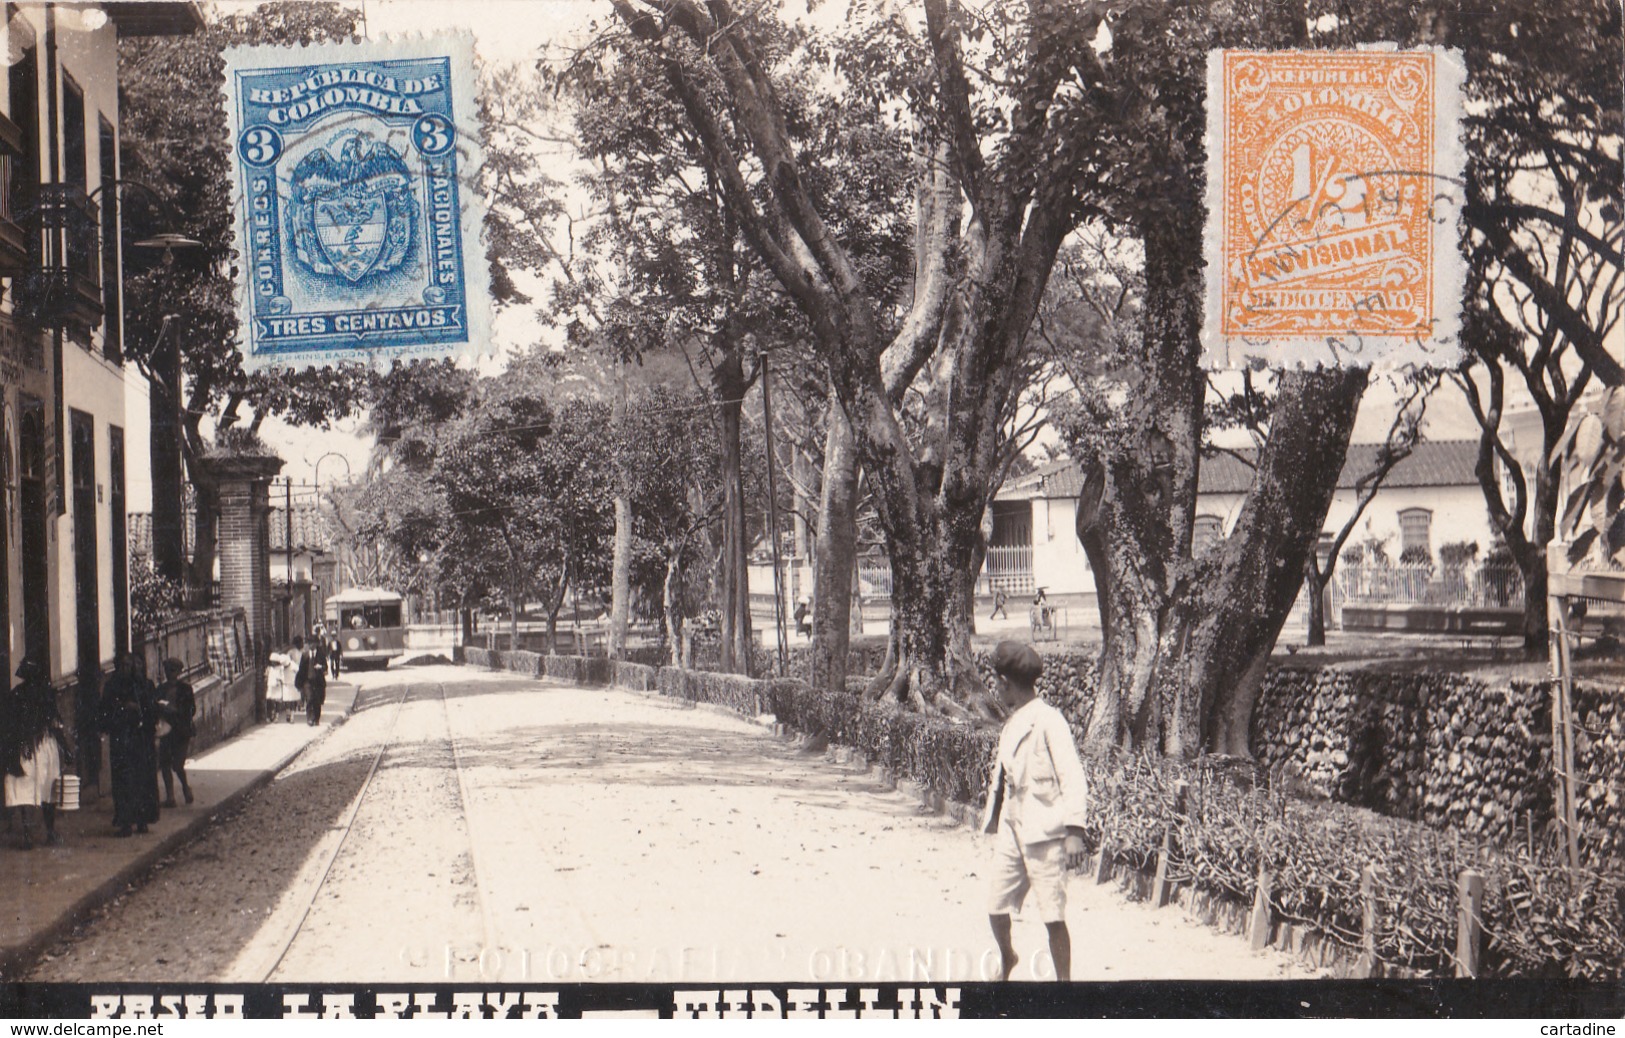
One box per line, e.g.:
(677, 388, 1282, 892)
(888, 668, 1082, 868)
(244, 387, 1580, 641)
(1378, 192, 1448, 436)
(1077, 226, 1367, 755)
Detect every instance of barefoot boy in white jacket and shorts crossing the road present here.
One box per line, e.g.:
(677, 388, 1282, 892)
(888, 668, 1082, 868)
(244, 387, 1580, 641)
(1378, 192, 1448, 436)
(982, 642, 1089, 981)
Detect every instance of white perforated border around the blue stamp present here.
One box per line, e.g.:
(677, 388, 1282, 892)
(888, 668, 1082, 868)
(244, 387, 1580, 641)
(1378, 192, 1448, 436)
(221, 29, 496, 374)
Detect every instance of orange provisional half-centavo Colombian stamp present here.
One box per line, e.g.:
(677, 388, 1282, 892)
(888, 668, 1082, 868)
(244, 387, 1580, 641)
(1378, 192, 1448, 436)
(1204, 49, 1466, 369)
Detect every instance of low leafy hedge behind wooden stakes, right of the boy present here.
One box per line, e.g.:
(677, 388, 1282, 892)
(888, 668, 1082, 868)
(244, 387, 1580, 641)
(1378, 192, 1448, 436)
(1089, 759, 1625, 980)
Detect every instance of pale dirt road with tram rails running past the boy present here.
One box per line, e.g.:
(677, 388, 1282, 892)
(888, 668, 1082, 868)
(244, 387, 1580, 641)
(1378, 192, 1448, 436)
(29, 668, 1310, 983)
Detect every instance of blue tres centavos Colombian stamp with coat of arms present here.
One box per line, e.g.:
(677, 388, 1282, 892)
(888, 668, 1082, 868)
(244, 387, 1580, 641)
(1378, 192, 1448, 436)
(226, 34, 491, 370)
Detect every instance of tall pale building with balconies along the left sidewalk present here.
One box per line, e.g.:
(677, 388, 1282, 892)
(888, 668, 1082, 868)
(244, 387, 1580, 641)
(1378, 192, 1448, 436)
(0, 3, 202, 723)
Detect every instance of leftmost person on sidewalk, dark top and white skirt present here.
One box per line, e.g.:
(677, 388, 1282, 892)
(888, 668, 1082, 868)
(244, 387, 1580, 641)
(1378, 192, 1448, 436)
(3, 656, 73, 851)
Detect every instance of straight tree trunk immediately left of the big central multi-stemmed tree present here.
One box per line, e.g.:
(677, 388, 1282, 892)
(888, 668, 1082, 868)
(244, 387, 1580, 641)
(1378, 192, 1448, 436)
(811, 398, 858, 692)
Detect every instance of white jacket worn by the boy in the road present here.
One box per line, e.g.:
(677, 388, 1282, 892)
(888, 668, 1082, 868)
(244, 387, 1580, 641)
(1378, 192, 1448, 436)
(982, 697, 1089, 843)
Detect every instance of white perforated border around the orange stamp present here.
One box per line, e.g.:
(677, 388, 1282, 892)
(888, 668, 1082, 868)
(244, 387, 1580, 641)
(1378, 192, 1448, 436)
(1201, 44, 1467, 370)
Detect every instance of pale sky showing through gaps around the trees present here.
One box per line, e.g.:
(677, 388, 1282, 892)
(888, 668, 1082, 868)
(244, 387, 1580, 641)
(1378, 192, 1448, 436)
(146, 0, 1501, 510)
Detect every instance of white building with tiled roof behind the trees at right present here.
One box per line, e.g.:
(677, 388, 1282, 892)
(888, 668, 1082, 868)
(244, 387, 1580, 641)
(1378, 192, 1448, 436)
(988, 440, 1495, 595)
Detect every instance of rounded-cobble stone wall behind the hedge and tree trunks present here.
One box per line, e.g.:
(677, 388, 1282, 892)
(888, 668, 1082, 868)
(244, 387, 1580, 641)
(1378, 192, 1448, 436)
(773, 650, 1625, 859)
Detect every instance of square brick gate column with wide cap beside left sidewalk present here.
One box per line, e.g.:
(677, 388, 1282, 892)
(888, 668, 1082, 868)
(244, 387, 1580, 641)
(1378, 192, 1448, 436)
(205, 456, 283, 720)
